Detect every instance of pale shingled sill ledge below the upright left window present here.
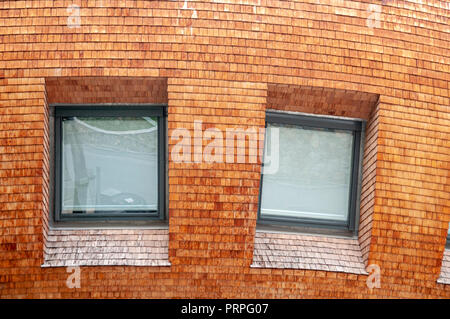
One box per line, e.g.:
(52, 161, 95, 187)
(41, 228, 171, 267)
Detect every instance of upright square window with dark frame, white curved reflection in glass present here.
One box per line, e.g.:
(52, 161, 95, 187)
(54, 105, 166, 221)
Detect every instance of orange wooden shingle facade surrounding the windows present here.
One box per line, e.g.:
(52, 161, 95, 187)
(0, 0, 450, 298)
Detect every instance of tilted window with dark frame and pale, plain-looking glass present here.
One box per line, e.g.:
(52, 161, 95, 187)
(258, 111, 364, 233)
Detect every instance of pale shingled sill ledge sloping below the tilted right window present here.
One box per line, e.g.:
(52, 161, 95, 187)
(250, 231, 368, 275)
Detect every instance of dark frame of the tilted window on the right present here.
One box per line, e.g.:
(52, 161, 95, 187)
(257, 110, 365, 235)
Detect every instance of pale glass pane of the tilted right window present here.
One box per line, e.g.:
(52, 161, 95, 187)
(261, 123, 353, 221)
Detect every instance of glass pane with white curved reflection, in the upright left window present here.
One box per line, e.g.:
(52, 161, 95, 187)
(61, 117, 158, 214)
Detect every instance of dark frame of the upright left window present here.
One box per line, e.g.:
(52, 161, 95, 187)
(51, 104, 167, 224)
